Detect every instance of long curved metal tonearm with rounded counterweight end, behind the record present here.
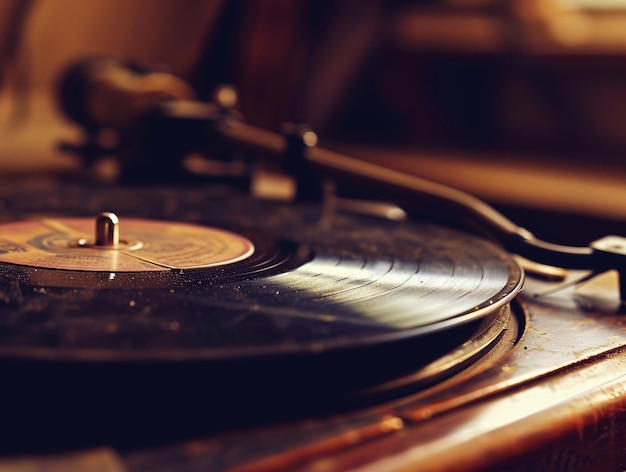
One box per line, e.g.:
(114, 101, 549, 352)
(60, 58, 626, 300)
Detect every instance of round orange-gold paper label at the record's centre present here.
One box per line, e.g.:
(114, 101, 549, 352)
(0, 218, 254, 272)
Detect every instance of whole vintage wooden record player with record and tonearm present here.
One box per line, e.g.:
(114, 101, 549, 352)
(0, 52, 626, 471)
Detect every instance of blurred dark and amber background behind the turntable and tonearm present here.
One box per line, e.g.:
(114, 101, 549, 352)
(0, 0, 626, 243)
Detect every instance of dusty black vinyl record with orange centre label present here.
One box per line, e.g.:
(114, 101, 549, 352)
(0, 206, 522, 361)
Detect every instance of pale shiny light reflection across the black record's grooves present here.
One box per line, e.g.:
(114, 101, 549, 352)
(260, 249, 521, 329)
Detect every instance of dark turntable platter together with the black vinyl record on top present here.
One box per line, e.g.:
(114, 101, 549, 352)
(0, 187, 523, 445)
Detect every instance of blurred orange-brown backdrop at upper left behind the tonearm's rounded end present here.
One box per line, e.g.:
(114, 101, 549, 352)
(0, 0, 222, 174)
